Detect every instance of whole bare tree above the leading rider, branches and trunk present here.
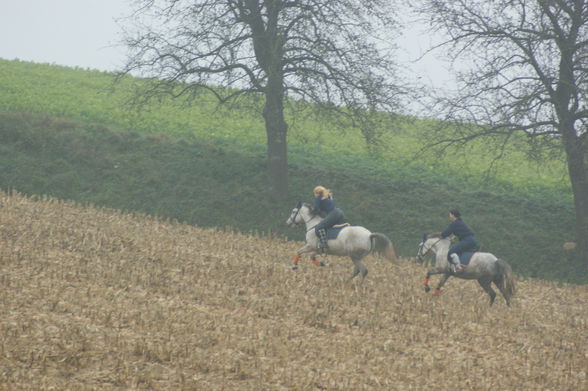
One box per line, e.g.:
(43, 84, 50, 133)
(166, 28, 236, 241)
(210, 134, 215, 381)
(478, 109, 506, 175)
(123, 0, 399, 199)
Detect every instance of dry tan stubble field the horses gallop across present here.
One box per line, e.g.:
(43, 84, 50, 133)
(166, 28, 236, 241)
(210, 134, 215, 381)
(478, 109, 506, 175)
(0, 193, 588, 391)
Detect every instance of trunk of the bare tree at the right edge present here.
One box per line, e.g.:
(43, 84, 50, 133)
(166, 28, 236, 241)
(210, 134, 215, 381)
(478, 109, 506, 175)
(564, 132, 588, 267)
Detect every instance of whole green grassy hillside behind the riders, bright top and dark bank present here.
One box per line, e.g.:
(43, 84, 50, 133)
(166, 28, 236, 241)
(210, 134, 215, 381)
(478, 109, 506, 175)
(0, 61, 588, 283)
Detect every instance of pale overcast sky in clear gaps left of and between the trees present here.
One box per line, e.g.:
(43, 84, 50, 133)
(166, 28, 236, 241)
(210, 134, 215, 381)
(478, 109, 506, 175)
(0, 0, 452, 88)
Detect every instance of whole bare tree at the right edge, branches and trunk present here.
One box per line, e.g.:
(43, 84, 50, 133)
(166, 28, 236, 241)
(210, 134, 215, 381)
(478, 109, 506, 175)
(419, 0, 588, 265)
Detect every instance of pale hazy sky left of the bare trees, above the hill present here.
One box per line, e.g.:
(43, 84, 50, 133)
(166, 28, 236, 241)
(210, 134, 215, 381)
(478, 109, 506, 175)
(0, 0, 130, 70)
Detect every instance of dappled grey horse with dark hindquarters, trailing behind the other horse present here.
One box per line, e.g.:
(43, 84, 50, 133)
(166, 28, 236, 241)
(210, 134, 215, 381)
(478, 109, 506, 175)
(417, 234, 515, 306)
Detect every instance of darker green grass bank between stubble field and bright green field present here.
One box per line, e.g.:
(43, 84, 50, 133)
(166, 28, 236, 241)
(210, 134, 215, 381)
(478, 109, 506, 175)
(0, 114, 587, 283)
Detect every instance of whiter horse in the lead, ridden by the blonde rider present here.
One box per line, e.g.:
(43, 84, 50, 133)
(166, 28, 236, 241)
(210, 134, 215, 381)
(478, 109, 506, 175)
(286, 202, 396, 282)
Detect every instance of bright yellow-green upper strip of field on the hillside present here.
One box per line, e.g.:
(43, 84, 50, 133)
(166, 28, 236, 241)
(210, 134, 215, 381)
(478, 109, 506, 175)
(0, 60, 570, 198)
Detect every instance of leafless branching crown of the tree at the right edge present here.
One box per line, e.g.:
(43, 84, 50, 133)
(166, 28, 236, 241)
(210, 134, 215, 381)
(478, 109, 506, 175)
(426, 0, 588, 140)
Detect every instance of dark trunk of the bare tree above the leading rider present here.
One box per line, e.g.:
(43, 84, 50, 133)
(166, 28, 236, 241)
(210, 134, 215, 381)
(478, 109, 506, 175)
(263, 71, 288, 201)
